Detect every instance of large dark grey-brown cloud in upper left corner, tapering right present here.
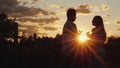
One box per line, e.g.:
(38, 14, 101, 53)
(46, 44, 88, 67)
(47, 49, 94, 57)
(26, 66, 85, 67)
(0, 0, 55, 17)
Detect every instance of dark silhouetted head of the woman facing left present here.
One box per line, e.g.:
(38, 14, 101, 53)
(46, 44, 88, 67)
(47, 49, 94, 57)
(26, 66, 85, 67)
(92, 16, 103, 27)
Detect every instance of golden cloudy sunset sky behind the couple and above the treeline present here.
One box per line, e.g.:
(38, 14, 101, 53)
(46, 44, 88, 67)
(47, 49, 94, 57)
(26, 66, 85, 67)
(0, 0, 120, 37)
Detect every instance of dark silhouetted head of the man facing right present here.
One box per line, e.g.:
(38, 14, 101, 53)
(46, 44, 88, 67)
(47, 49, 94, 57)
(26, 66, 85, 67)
(67, 8, 76, 21)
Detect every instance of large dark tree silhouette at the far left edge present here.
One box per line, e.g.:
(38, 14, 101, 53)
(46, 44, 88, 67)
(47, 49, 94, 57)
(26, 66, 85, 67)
(0, 12, 18, 45)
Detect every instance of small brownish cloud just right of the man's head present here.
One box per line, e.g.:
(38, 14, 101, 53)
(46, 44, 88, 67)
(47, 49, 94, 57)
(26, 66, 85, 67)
(77, 4, 91, 14)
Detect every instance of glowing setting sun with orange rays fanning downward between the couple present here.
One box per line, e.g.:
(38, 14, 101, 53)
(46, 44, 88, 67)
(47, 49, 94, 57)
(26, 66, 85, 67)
(62, 33, 107, 67)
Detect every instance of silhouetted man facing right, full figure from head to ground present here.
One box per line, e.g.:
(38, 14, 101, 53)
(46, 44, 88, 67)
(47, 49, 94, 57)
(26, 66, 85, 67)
(62, 8, 77, 68)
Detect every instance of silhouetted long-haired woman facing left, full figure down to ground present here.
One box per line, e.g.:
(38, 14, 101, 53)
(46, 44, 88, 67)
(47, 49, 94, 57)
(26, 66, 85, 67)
(90, 16, 106, 68)
